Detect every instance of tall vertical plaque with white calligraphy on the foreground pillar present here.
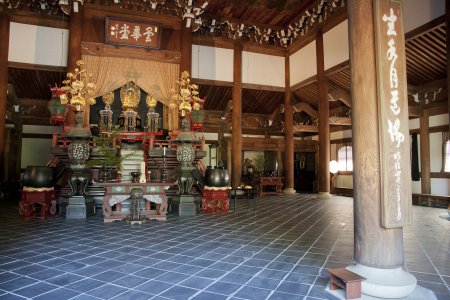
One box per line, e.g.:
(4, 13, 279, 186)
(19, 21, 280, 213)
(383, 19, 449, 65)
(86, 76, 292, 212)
(373, 0, 411, 228)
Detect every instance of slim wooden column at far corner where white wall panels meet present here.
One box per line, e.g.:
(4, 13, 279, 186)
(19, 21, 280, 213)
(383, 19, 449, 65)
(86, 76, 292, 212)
(283, 56, 295, 195)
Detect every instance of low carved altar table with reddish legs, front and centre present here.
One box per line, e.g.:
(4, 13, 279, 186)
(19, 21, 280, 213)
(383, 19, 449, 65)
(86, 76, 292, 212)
(96, 181, 175, 223)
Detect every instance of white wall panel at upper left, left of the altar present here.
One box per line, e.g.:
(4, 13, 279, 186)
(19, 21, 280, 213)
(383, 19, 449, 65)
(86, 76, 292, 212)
(8, 22, 69, 67)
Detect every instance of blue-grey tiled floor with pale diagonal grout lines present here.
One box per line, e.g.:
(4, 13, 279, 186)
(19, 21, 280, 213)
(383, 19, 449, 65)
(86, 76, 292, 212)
(0, 194, 450, 300)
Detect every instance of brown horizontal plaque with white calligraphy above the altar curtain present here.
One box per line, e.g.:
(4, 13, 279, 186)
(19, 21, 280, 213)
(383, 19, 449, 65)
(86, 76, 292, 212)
(105, 17, 161, 49)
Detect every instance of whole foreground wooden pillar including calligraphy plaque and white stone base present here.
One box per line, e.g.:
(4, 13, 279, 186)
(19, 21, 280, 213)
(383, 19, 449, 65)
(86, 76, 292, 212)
(347, 0, 417, 298)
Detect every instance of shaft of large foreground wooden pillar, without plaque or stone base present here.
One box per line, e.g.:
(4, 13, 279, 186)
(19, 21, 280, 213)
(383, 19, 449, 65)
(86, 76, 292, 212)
(347, 0, 403, 268)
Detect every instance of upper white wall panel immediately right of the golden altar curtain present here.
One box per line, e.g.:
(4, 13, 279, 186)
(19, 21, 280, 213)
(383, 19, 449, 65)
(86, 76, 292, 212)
(192, 45, 233, 82)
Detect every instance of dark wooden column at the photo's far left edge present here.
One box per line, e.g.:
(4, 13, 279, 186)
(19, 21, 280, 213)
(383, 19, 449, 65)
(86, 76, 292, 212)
(0, 13, 10, 182)
